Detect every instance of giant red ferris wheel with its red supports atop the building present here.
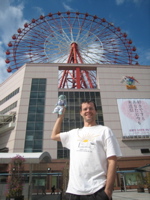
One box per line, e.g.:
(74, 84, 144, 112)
(5, 11, 138, 88)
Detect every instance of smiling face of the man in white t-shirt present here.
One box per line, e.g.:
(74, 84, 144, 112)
(80, 102, 97, 123)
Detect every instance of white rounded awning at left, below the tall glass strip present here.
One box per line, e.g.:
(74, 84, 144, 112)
(0, 152, 51, 164)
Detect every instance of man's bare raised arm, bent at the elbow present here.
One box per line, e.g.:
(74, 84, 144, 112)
(51, 108, 65, 141)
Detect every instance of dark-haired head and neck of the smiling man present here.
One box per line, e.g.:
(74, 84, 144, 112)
(80, 100, 97, 126)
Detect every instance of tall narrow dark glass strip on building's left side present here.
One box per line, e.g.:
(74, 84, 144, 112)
(24, 79, 46, 152)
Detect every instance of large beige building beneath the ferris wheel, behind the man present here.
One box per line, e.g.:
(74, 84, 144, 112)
(0, 64, 150, 197)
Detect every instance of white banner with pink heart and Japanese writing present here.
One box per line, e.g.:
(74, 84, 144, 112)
(117, 99, 150, 137)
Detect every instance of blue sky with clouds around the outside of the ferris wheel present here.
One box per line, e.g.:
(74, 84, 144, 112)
(0, 0, 150, 84)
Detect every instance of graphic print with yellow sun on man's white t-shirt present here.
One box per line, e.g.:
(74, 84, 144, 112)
(77, 132, 99, 152)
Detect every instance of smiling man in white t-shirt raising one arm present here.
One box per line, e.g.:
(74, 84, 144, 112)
(51, 101, 121, 200)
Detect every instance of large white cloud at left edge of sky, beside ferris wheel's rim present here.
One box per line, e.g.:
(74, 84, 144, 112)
(0, 0, 26, 83)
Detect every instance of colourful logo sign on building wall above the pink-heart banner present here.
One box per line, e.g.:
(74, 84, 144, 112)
(121, 76, 138, 89)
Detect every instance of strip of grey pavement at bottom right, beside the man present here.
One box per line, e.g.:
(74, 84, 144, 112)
(113, 189, 150, 200)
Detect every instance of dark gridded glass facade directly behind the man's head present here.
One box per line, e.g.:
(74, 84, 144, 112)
(57, 90, 103, 158)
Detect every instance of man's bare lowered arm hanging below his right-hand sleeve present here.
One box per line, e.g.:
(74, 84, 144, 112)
(105, 156, 117, 199)
